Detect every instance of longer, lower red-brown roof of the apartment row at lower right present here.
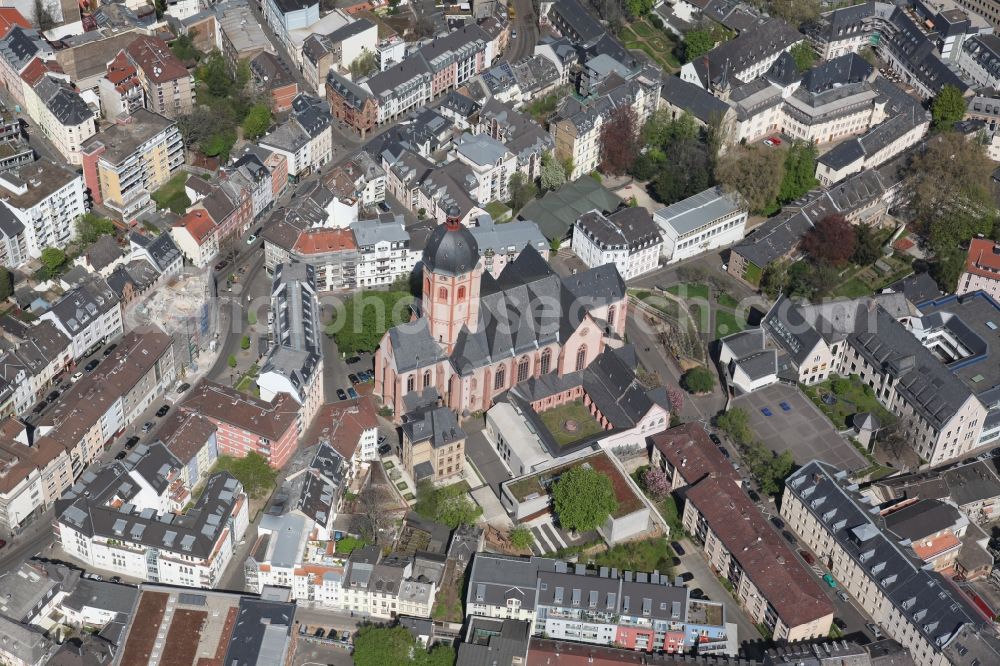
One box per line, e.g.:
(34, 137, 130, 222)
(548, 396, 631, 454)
(687, 477, 833, 628)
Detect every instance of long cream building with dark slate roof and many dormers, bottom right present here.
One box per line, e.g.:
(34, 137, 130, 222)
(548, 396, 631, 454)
(781, 460, 992, 666)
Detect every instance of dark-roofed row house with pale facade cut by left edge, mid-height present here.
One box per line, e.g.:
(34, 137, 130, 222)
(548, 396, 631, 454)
(0, 317, 73, 418)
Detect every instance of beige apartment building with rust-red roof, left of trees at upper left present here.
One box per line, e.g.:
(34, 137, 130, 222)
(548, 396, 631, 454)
(125, 35, 194, 119)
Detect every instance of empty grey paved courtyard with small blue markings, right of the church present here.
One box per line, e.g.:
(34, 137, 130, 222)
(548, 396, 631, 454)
(733, 384, 868, 471)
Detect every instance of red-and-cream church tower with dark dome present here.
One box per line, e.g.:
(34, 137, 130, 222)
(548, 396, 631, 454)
(422, 206, 483, 353)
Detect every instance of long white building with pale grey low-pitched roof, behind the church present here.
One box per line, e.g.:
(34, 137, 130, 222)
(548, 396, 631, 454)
(653, 187, 747, 263)
